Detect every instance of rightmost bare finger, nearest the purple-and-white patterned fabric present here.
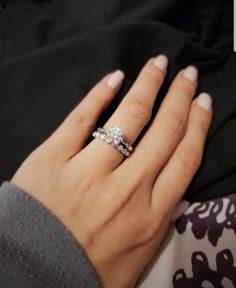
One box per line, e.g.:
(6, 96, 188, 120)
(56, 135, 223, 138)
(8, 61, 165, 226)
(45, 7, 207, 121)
(151, 93, 212, 211)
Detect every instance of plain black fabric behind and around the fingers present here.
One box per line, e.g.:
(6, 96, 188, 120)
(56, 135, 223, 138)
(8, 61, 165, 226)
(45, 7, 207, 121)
(0, 0, 236, 201)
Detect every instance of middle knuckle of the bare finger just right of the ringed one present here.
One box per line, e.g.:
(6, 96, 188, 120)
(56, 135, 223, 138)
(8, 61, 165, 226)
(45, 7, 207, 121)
(163, 111, 186, 139)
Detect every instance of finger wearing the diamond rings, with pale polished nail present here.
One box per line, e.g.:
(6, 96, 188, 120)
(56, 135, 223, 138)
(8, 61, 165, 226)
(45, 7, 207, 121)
(83, 55, 168, 170)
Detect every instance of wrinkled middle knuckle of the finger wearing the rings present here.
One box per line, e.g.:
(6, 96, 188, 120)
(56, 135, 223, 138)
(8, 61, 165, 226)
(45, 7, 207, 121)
(126, 100, 151, 128)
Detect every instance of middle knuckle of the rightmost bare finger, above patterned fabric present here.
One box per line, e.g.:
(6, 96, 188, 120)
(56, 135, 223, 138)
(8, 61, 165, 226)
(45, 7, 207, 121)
(178, 147, 201, 175)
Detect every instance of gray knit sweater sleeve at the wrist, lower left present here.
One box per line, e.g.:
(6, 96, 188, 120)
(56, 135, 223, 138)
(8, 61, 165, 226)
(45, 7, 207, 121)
(0, 182, 101, 288)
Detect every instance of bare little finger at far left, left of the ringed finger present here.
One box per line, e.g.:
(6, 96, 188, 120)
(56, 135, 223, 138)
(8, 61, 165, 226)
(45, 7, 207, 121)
(41, 70, 124, 159)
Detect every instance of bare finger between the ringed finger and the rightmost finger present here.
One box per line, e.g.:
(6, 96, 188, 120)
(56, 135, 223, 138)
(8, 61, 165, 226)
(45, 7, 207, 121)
(124, 66, 198, 181)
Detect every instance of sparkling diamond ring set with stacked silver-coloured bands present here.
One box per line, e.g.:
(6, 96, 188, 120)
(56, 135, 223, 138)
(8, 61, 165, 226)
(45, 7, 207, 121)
(93, 127, 133, 157)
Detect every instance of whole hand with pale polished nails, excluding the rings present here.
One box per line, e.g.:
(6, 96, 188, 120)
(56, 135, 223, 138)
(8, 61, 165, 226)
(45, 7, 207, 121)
(11, 56, 212, 288)
